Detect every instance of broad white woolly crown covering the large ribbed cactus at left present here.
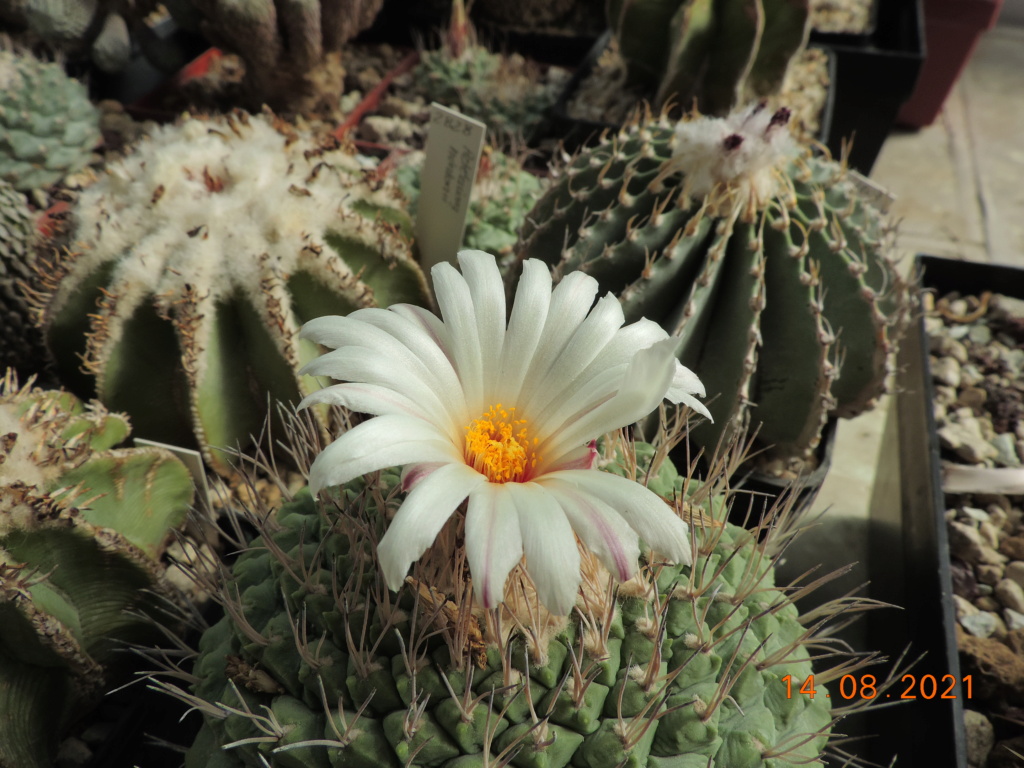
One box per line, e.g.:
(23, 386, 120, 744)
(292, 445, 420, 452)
(54, 115, 394, 315)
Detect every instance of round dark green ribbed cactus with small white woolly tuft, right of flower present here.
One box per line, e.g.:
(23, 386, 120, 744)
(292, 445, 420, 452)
(518, 106, 911, 473)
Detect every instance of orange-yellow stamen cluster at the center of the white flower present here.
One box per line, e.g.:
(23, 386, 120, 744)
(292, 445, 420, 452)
(466, 402, 538, 482)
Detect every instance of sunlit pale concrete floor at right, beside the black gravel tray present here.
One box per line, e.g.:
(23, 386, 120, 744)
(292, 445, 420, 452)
(814, 13, 1024, 522)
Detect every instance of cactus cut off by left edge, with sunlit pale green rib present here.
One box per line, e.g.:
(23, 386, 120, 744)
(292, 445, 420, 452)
(0, 371, 193, 768)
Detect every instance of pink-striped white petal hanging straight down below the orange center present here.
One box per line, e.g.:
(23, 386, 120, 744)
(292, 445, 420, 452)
(466, 482, 522, 609)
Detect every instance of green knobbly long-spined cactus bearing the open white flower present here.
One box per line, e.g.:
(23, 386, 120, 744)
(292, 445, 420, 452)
(151, 409, 873, 768)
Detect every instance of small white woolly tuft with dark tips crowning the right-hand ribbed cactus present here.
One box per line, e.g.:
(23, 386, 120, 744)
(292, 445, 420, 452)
(672, 104, 800, 200)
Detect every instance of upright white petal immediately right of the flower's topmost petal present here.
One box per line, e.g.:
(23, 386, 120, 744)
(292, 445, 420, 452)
(488, 259, 551, 404)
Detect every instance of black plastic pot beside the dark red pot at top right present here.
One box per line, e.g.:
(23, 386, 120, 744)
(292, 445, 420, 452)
(824, 0, 925, 175)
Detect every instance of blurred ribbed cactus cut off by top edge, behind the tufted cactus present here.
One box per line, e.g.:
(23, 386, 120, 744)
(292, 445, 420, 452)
(607, 0, 809, 115)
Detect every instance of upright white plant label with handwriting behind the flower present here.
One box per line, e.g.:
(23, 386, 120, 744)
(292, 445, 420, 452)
(416, 103, 487, 270)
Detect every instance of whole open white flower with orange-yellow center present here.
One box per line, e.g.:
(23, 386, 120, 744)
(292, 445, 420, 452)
(301, 251, 710, 615)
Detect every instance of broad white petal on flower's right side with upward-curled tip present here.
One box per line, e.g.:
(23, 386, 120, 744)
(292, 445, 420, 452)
(538, 339, 676, 457)
